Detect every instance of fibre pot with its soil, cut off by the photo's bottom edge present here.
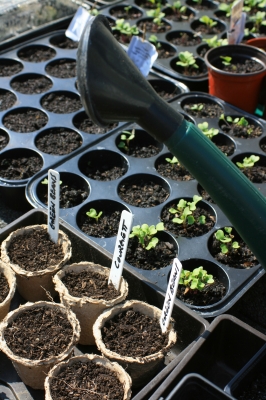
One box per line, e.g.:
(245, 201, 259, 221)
(44, 354, 132, 400)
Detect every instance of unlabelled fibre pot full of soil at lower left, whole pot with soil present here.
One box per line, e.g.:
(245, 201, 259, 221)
(0, 301, 80, 390)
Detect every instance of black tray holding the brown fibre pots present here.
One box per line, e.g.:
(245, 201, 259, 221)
(0, 209, 209, 400)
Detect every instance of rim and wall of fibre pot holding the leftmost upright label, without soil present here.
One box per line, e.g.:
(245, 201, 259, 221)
(1, 224, 72, 301)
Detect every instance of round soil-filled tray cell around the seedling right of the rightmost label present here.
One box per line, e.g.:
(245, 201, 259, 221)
(172, 258, 230, 312)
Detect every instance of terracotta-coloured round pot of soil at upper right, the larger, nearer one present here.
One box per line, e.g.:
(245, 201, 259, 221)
(205, 45, 266, 113)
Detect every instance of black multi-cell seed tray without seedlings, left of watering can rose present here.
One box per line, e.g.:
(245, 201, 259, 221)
(0, 20, 188, 209)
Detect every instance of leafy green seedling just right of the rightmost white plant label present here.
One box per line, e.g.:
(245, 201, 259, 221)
(179, 267, 214, 294)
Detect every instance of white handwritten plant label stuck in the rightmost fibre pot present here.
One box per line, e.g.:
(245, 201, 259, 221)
(160, 258, 182, 333)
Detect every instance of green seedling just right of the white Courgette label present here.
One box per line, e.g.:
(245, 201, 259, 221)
(129, 222, 164, 250)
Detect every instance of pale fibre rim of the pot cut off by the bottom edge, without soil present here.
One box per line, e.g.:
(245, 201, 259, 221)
(44, 354, 132, 400)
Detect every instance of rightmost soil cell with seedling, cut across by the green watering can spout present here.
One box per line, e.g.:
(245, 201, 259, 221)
(208, 226, 259, 269)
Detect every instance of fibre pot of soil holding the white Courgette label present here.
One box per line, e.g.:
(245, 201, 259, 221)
(53, 262, 128, 345)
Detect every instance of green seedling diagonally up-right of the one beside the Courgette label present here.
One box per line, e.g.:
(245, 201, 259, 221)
(169, 194, 206, 226)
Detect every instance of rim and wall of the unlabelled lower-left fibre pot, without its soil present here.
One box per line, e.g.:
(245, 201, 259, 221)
(0, 301, 80, 389)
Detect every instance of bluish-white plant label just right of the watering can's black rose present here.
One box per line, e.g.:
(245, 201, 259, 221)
(127, 36, 158, 77)
